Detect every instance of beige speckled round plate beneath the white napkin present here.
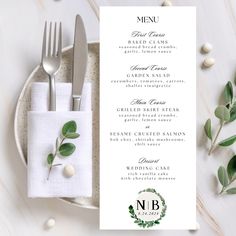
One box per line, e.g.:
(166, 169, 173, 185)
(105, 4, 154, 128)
(14, 43, 99, 209)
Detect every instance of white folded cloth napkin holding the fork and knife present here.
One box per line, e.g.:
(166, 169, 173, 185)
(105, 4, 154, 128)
(28, 83, 92, 197)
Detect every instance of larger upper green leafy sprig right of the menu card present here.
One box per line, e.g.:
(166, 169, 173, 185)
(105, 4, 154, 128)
(204, 81, 236, 155)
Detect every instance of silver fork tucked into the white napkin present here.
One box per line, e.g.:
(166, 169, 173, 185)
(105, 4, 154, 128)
(41, 22, 62, 111)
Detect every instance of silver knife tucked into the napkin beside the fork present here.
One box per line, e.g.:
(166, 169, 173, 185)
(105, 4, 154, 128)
(72, 15, 88, 111)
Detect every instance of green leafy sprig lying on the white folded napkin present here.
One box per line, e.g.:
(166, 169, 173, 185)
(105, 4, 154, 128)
(47, 120, 80, 180)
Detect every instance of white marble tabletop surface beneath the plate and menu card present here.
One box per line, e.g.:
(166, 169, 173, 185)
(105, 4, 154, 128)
(0, 0, 236, 236)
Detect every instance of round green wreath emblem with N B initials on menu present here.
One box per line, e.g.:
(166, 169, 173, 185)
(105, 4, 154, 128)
(129, 188, 167, 228)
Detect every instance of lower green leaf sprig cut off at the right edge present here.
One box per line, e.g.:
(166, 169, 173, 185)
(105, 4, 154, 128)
(218, 155, 236, 194)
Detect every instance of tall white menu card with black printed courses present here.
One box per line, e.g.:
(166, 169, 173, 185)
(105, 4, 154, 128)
(100, 7, 196, 230)
